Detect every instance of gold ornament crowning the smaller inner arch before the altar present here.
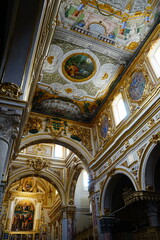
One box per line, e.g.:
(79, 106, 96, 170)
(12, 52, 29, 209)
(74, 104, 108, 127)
(28, 157, 50, 171)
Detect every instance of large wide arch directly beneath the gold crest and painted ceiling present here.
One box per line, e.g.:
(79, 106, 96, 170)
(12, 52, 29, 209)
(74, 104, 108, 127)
(20, 133, 93, 167)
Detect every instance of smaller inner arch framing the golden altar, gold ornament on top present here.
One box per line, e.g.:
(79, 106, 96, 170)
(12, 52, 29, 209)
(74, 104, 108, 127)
(4, 168, 66, 205)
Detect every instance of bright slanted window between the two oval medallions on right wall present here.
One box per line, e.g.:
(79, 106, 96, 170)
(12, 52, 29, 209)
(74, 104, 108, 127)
(112, 94, 127, 125)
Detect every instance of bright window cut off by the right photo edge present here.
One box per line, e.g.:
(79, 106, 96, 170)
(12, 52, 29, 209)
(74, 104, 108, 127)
(148, 40, 160, 78)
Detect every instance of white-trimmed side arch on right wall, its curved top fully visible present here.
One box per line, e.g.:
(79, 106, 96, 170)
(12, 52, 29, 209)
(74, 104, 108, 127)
(100, 168, 138, 215)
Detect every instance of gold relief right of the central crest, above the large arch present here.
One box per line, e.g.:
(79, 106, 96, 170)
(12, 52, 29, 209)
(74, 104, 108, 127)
(68, 124, 92, 152)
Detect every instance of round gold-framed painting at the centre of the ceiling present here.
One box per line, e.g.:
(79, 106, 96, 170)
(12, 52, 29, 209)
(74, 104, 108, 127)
(62, 53, 95, 82)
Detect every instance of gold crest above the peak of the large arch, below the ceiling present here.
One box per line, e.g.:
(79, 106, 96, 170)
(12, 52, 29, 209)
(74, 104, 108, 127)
(46, 118, 67, 138)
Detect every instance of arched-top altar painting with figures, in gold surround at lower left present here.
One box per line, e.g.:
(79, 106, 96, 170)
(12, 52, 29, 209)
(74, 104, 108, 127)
(12, 200, 34, 231)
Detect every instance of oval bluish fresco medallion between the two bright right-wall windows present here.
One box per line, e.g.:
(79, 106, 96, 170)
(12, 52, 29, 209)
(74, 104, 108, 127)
(129, 72, 146, 100)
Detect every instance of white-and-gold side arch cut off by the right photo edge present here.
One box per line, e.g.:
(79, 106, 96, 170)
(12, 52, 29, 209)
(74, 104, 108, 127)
(139, 142, 160, 190)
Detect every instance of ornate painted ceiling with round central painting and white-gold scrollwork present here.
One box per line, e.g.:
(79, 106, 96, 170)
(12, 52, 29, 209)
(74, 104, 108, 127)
(32, 0, 159, 122)
